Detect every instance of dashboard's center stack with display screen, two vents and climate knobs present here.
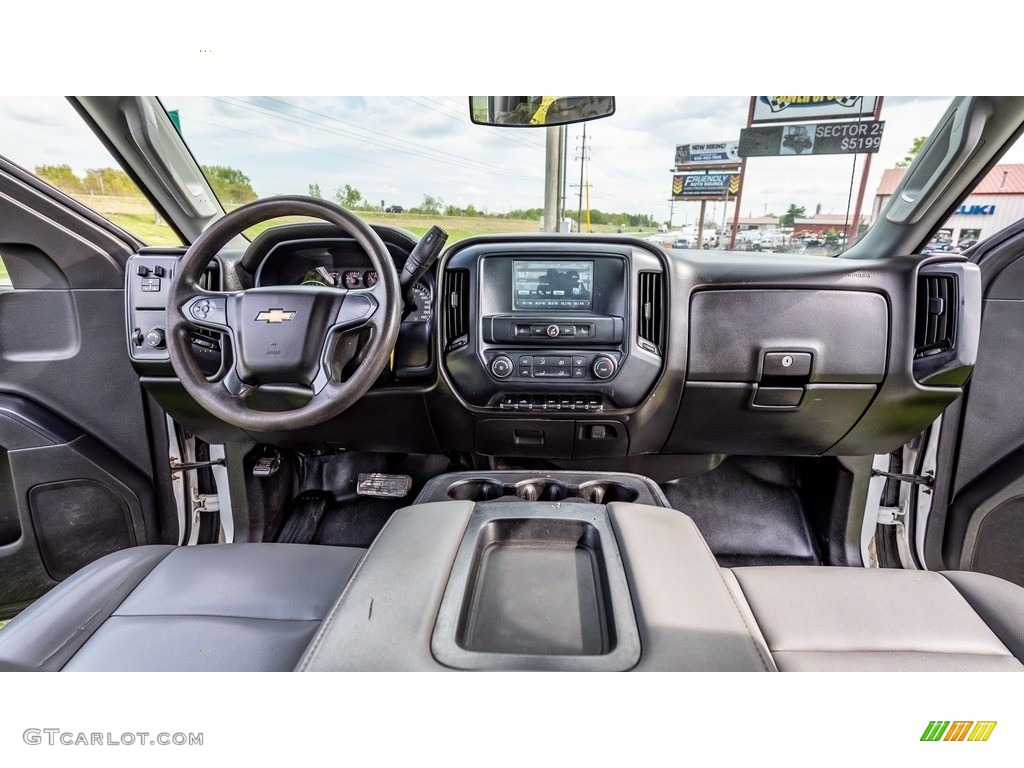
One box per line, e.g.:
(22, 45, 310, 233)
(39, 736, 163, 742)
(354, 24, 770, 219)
(438, 238, 668, 458)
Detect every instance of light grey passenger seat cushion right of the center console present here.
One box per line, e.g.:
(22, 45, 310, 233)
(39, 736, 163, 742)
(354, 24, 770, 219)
(730, 566, 1024, 672)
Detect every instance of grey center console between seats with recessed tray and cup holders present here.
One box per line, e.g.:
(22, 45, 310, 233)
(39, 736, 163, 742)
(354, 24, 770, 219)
(299, 472, 770, 672)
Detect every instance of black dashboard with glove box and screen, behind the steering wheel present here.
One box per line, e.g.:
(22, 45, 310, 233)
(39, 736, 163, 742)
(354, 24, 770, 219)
(126, 225, 981, 467)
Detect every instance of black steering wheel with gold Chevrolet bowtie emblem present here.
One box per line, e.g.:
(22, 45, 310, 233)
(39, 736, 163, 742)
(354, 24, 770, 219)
(167, 196, 402, 431)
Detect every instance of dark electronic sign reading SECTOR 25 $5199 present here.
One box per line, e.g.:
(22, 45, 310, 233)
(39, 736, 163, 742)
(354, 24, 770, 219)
(739, 120, 886, 158)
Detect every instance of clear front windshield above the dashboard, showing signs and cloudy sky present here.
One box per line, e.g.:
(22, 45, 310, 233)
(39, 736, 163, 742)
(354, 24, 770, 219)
(153, 96, 974, 255)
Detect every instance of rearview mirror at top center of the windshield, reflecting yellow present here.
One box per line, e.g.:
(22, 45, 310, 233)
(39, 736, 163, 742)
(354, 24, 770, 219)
(469, 96, 615, 128)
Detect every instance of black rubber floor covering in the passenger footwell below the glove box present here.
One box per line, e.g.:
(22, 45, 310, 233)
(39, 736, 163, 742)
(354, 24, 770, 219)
(660, 457, 821, 567)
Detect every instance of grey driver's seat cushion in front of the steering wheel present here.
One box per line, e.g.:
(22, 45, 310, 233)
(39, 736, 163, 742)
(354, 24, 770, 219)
(0, 544, 366, 672)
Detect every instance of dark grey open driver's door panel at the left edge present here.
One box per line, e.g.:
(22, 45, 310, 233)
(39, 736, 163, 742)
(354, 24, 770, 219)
(0, 158, 169, 617)
